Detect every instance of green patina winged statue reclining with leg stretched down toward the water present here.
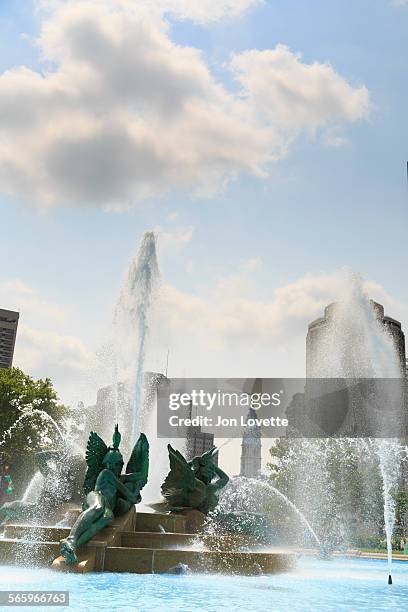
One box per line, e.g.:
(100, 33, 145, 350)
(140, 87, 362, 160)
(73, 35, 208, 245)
(60, 425, 149, 565)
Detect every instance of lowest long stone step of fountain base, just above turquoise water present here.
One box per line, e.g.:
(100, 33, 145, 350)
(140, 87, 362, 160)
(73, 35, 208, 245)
(104, 546, 296, 576)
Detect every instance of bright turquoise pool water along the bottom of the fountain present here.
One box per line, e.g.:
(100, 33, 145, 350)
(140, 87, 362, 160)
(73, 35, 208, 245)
(0, 559, 408, 612)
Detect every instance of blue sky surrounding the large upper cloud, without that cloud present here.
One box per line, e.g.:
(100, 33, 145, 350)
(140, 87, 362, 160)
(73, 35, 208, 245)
(0, 0, 408, 426)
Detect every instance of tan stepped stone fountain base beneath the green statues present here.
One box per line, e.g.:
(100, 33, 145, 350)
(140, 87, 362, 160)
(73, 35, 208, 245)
(0, 510, 296, 575)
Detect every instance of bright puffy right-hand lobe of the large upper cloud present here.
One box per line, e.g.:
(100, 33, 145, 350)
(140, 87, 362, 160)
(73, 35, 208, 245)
(231, 45, 368, 135)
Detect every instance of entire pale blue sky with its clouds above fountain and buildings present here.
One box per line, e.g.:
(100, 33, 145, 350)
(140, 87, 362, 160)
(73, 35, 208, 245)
(0, 0, 408, 474)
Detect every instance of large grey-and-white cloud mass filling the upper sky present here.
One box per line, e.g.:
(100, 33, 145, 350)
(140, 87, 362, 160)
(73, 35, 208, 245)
(0, 0, 368, 208)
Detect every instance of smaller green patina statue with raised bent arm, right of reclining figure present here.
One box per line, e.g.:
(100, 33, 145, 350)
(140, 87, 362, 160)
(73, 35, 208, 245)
(161, 444, 229, 514)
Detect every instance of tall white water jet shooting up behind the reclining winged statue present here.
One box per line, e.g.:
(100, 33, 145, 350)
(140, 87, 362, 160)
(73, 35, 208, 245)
(110, 232, 183, 500)
